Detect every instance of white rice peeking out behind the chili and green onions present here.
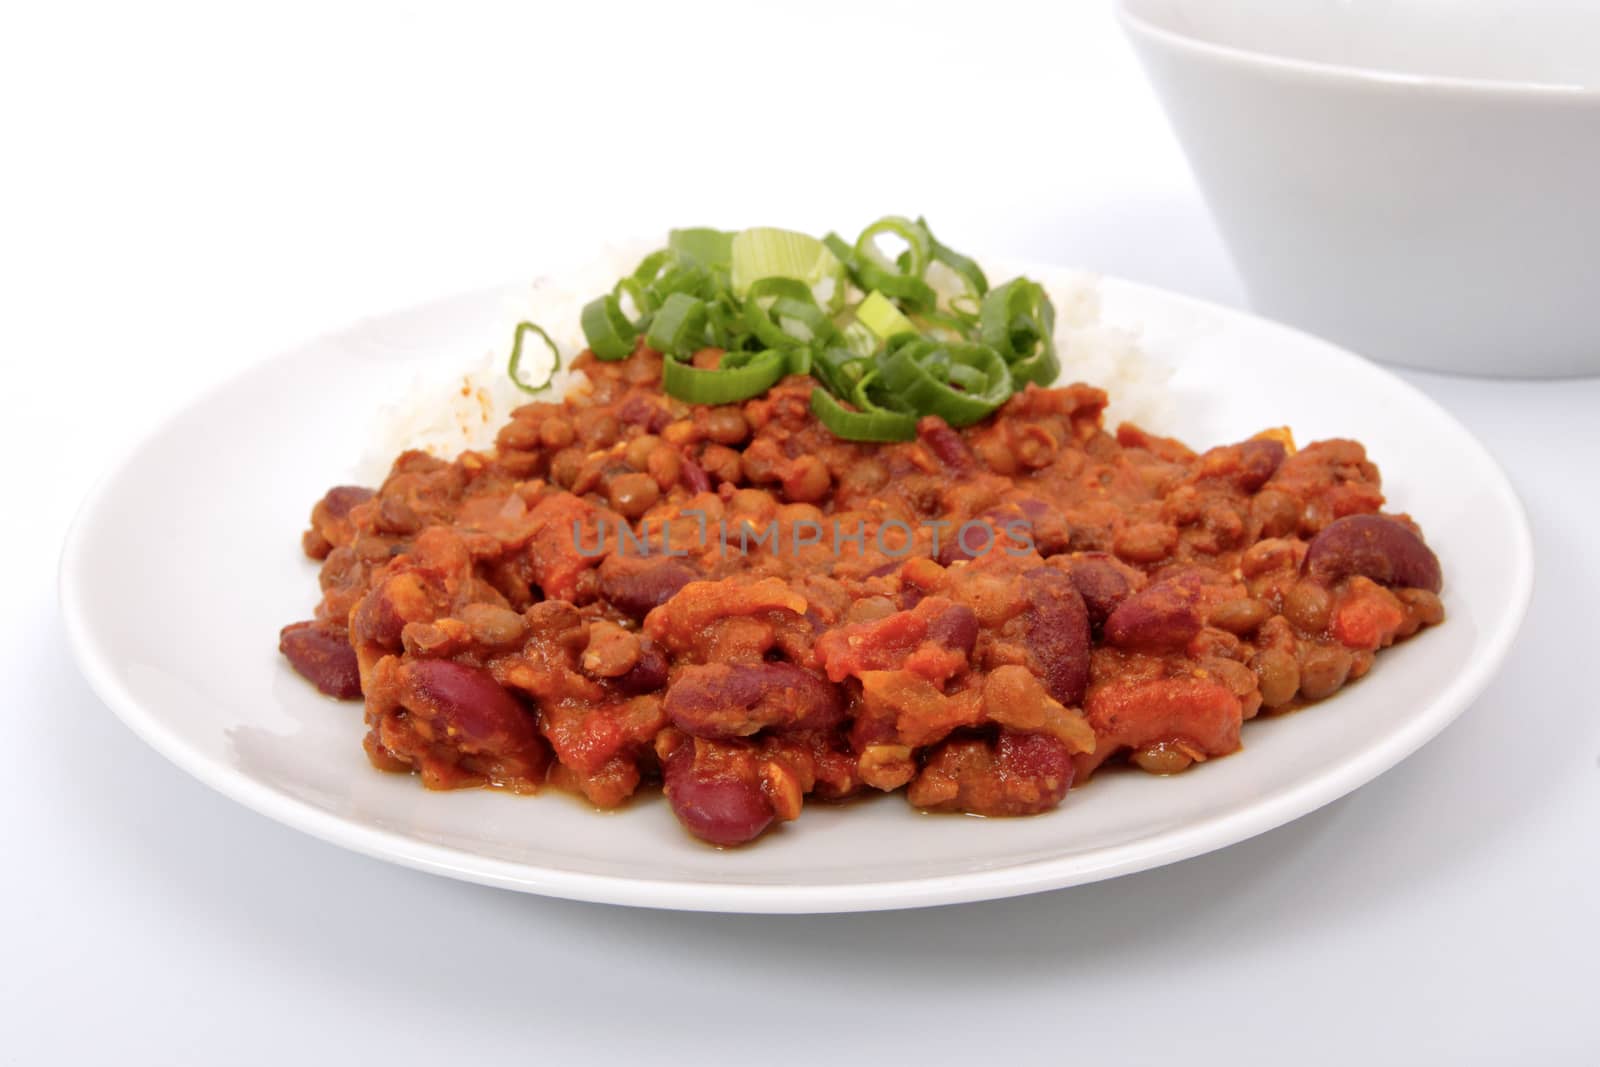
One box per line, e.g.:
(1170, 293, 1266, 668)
(358, 240, 1171, 485)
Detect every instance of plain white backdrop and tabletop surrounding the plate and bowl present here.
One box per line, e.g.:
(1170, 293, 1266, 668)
(0, 0, 1600, 1064)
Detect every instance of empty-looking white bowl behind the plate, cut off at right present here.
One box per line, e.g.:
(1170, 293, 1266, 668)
(1118, 0, 1600, 378)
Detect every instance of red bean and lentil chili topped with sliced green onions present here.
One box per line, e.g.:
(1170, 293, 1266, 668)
(280, 218, 1443, 845)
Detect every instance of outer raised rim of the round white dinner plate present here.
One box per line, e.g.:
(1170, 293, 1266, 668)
(56, 271, 1536, 913)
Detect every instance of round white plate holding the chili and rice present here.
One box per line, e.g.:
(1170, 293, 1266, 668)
(61, 267, 1533, 912)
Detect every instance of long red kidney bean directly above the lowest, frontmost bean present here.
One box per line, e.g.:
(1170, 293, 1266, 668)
(664, 662, 845, 737)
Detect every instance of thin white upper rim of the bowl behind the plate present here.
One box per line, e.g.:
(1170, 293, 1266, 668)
(1115, 0, 1600, 104)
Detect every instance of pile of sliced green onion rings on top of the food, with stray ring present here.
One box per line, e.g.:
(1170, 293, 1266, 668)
(510, 214, 1061, 442)
